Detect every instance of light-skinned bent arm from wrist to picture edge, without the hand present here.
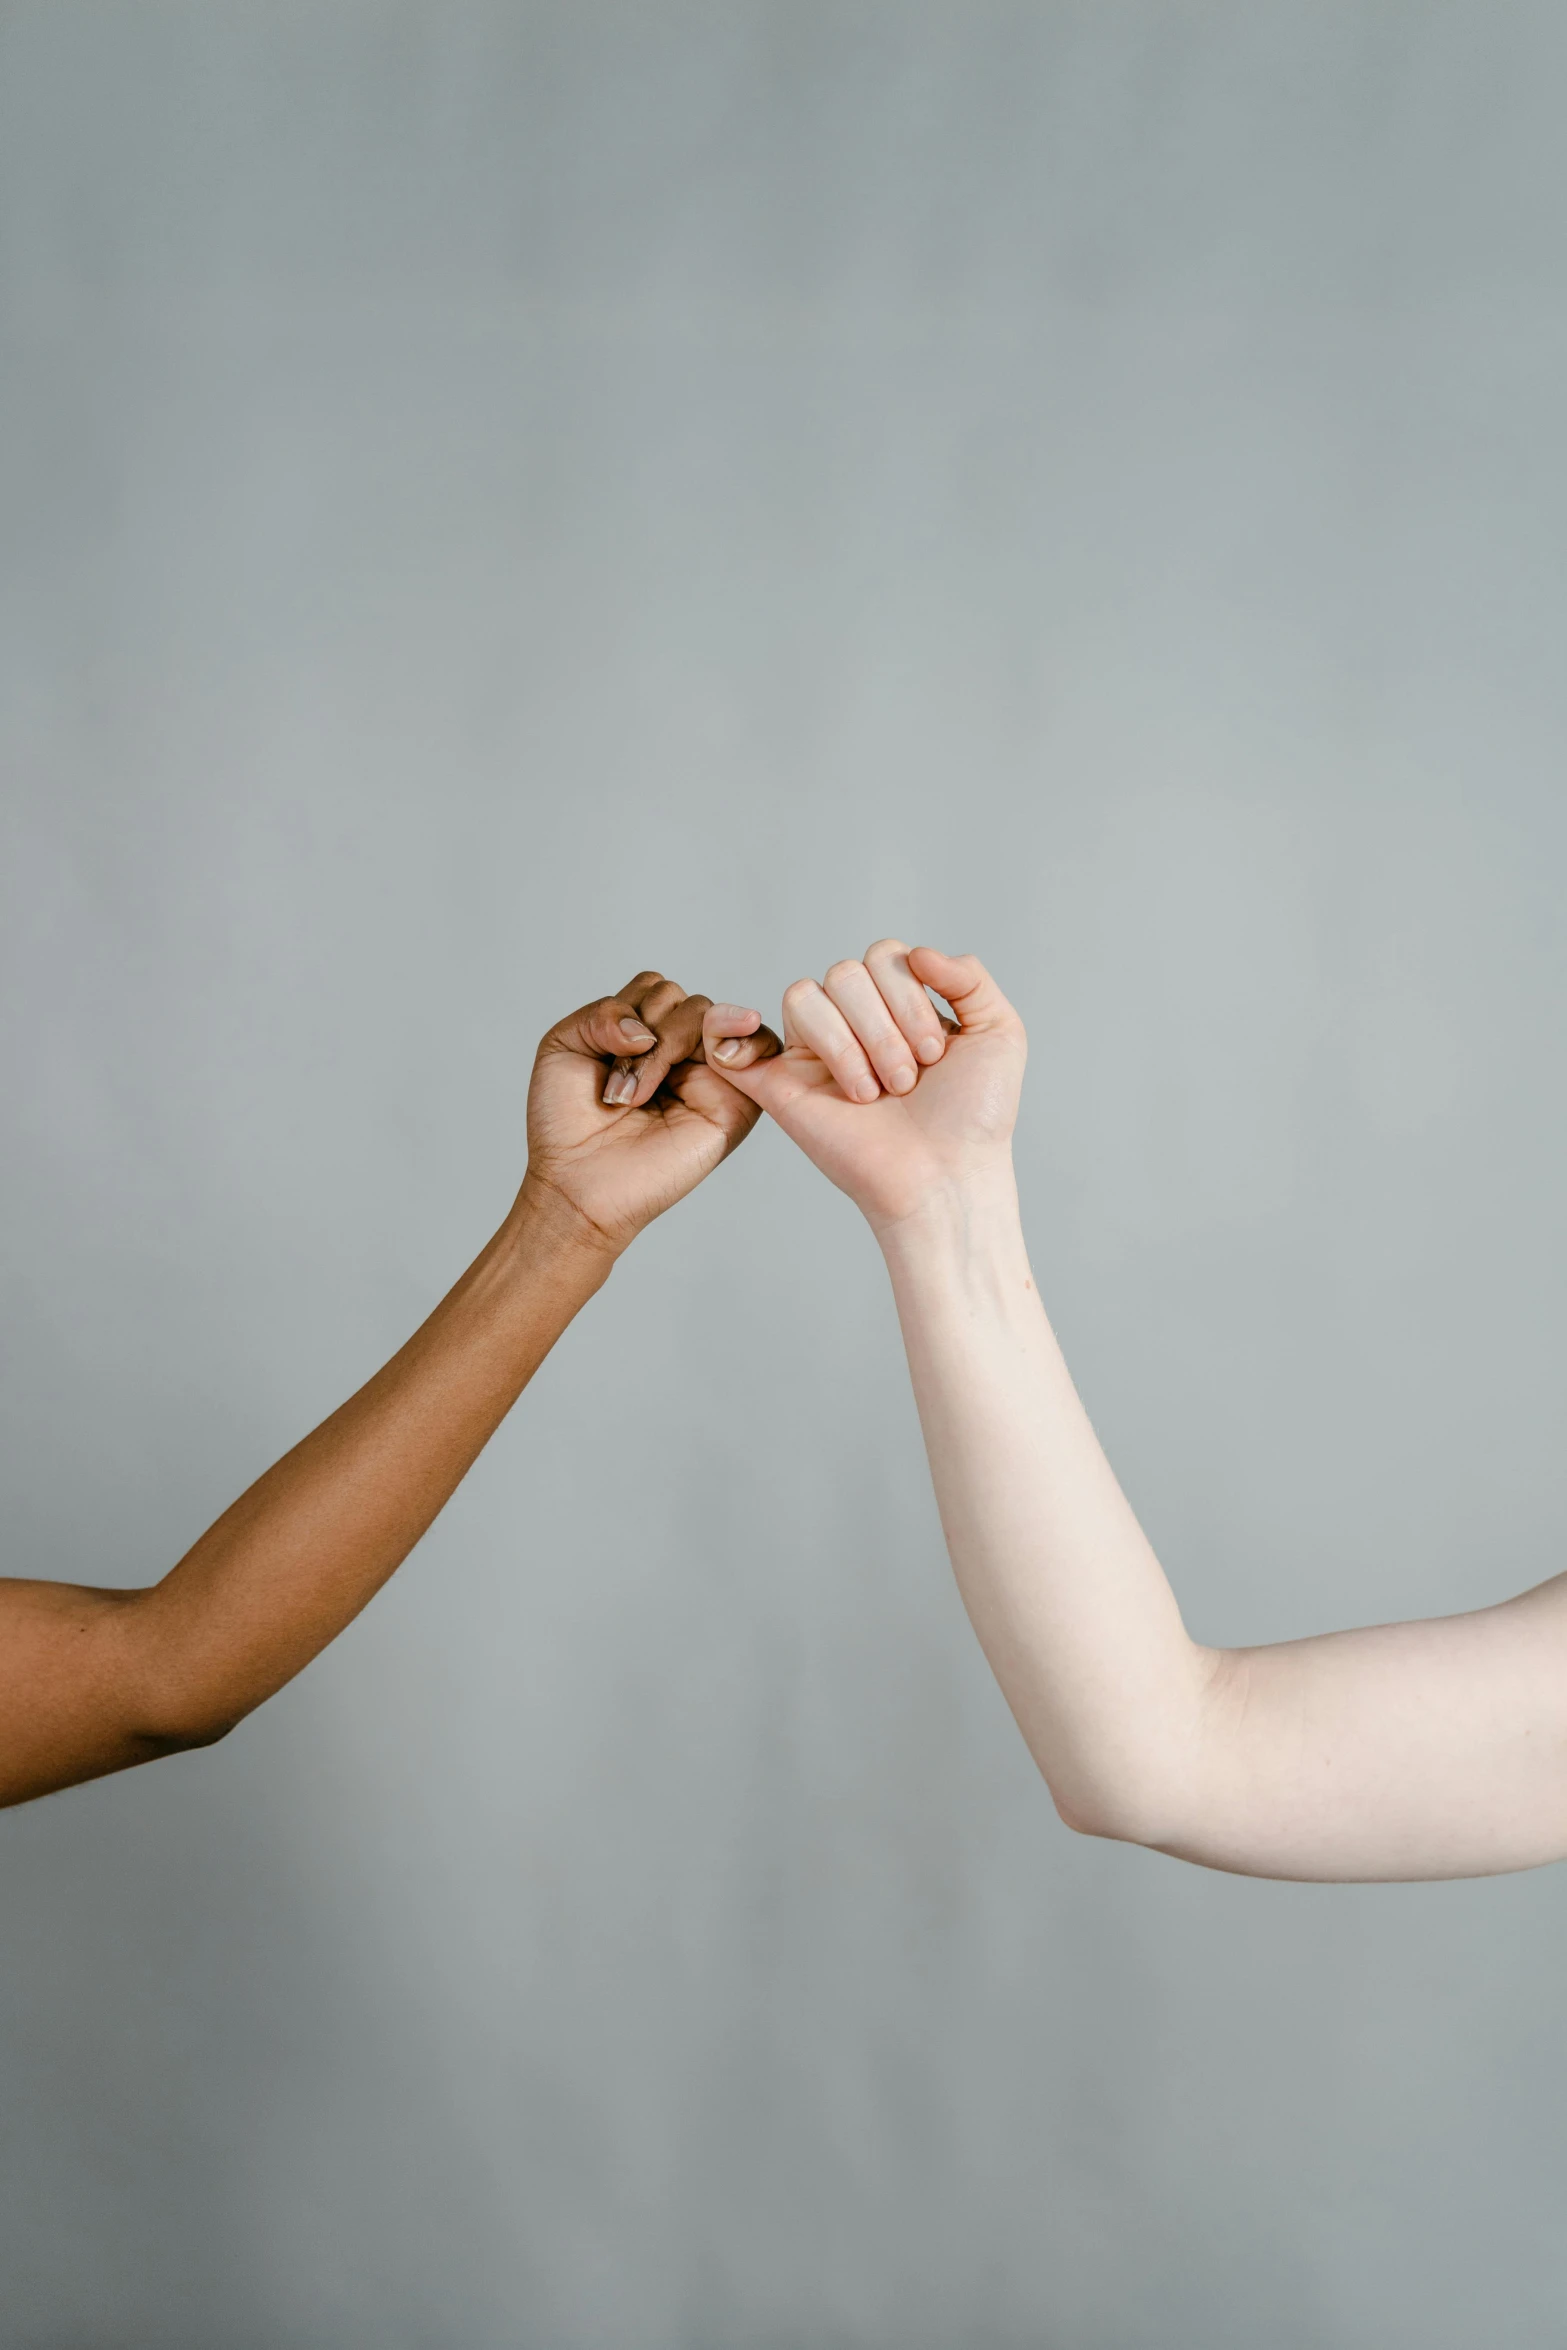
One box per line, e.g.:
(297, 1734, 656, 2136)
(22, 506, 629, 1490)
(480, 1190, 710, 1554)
(883, 1175, 1567, 1880)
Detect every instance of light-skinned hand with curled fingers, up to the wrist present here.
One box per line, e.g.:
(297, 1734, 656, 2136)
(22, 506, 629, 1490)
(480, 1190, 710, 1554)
(702, 938, 1029, 1231)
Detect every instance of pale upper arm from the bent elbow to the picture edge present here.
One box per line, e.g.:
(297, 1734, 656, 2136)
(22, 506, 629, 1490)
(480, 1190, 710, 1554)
(1158, 1575, 1567, 1878)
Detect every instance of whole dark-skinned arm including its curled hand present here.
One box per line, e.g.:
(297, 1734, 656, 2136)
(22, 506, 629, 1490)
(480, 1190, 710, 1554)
(0, 971, 775, 1805)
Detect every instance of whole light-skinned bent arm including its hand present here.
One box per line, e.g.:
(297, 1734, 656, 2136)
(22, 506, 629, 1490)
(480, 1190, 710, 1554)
(707, 940, 1567, 1880)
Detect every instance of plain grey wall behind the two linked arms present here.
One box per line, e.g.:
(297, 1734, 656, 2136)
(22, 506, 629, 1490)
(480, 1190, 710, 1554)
(0, 0, 1567, 2350)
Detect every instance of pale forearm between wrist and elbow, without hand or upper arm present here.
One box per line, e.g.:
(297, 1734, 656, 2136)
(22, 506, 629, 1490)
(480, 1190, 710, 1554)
(881, 1168, 1217, 1842)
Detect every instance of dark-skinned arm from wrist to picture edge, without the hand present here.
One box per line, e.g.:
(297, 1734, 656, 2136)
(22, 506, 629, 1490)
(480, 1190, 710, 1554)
(0, 1187, 611, 1802)
